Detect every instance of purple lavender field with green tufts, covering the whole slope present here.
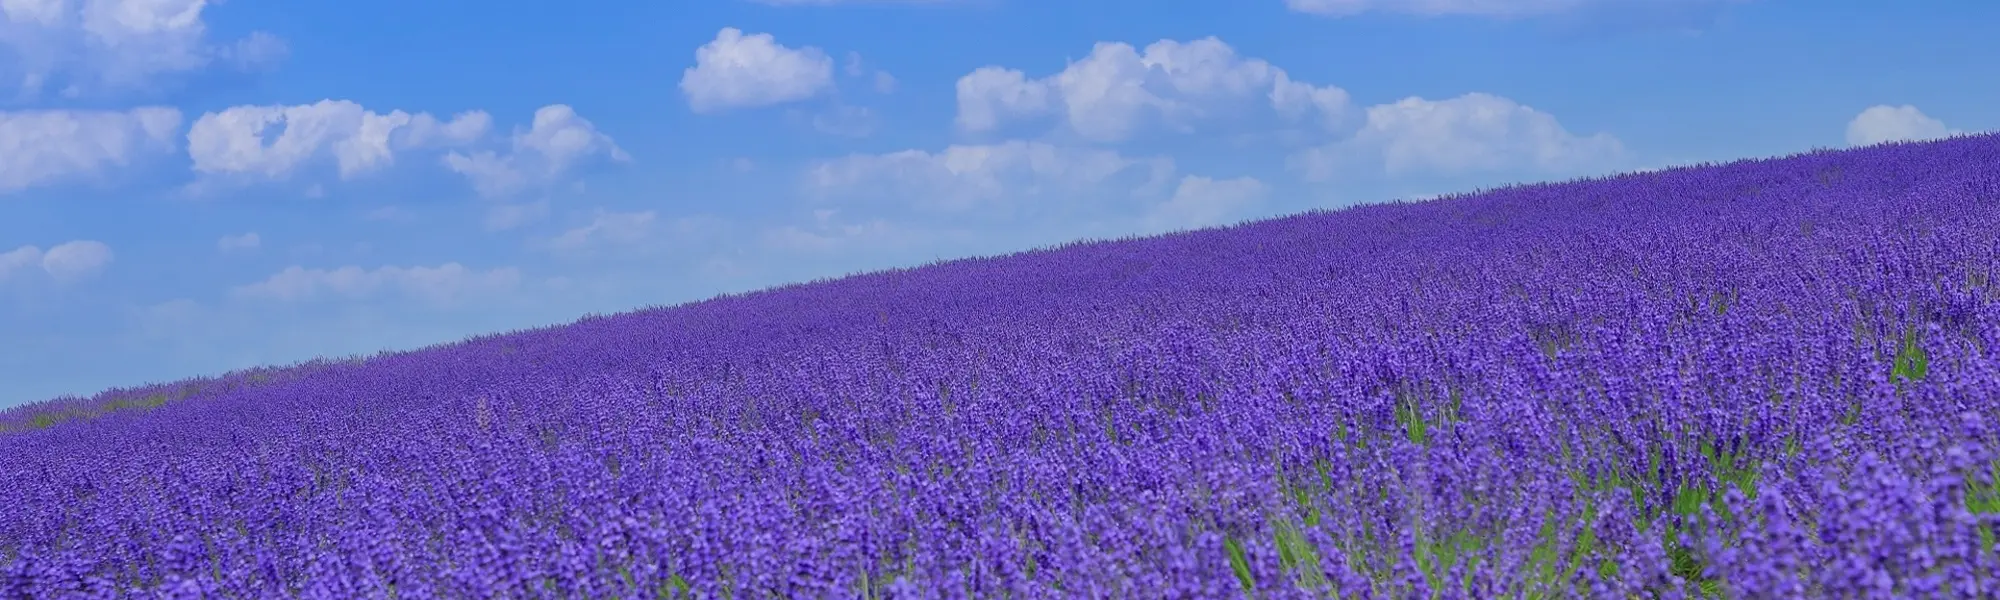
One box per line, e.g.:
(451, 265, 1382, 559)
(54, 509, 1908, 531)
(0, 136, 2000, 598)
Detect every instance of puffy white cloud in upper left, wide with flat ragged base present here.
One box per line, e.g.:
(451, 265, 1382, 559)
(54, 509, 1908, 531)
(188, 100, 492, 180)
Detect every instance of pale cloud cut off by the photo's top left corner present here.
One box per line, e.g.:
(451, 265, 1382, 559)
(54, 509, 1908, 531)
(0, 0, 286, 96)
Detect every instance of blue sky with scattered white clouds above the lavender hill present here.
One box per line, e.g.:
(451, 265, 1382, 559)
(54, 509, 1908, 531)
(0, 0, 2000, 406)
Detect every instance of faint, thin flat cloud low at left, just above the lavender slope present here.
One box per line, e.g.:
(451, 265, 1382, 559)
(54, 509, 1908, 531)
(232, 262, 520, 304)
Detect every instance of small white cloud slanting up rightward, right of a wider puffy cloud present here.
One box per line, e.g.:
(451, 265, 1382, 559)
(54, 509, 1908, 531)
(444, 104, 632, 198)
